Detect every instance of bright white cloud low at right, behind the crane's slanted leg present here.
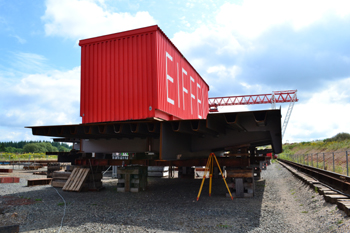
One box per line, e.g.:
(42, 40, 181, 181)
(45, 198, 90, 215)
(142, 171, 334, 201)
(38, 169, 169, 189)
(283, 78, 350, 142)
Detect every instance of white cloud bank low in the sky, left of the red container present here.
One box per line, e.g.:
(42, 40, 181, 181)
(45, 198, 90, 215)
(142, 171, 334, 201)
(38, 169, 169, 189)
(0, 67, 81, 141)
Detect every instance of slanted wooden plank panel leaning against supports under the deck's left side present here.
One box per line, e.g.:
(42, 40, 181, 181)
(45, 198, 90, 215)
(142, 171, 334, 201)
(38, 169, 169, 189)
(62, 168, 90, 192)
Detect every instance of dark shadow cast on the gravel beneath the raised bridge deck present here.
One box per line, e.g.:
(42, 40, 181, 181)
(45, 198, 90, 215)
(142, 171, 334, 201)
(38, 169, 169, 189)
(2, 175, 265, 232)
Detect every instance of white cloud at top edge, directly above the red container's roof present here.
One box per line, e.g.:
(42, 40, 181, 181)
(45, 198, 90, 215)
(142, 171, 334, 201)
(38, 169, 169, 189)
(42, 0, 156, 39)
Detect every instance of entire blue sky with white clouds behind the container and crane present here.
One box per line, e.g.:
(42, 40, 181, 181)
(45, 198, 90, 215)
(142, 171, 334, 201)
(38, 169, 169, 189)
(0, 0, 350, 142)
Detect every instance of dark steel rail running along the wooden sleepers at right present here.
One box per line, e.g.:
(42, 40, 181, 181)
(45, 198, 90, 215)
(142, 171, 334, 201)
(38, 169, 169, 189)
(278, 159, 350, 194)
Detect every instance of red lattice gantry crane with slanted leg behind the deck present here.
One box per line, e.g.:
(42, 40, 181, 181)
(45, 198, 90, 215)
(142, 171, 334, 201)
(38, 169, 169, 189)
(209, 90, 298, 138)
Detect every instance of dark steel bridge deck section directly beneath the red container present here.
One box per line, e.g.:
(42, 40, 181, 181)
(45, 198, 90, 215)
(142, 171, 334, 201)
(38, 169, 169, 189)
(28, 109, 282, 160)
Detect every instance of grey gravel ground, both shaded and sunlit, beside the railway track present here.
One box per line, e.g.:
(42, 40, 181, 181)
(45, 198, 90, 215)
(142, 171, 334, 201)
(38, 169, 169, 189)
(0, 164, 350, 233)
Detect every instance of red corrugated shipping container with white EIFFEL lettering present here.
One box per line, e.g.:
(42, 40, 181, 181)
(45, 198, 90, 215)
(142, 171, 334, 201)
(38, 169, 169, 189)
(79, 26, 209, 123)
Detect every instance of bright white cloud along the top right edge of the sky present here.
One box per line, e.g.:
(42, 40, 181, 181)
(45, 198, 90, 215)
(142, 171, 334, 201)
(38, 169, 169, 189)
(216, 0, 350, 38)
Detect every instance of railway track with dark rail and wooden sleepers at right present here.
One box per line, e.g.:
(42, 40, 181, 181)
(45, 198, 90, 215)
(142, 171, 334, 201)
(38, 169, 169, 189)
(278, 159, 350, 216)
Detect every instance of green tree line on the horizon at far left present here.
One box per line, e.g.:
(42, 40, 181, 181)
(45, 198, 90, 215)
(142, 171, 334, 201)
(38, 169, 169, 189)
(0, 141, 72, 153)
